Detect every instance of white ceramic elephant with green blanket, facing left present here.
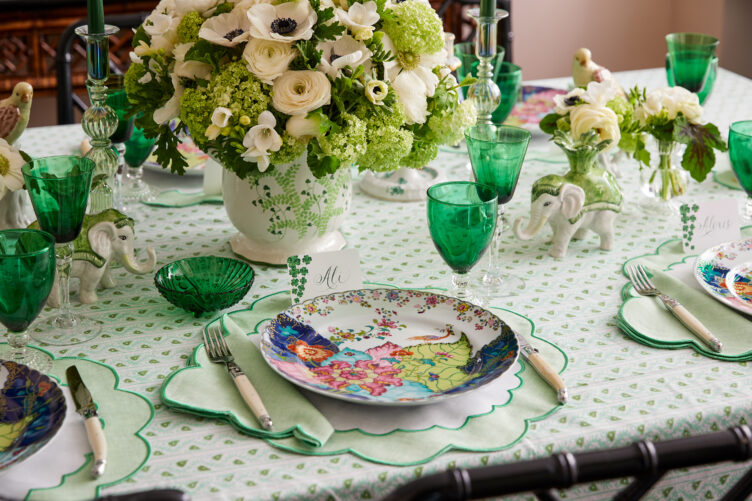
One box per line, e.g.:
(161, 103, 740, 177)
(513, 167, 623, 258)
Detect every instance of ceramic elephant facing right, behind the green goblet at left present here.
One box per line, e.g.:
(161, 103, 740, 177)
(34, 209, 157, 306)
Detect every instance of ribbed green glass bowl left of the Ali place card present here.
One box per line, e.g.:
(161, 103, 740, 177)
(154, 256, 255, 317)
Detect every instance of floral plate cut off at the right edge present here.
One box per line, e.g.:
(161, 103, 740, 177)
(695, 238, 752, 315)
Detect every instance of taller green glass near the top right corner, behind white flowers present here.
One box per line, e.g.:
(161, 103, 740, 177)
(666, 33, 718, 93)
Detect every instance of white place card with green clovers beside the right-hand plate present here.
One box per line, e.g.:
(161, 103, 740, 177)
(680, 199, 742, 254)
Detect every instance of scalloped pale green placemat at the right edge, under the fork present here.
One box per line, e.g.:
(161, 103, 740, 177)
(617, 226, 752, 362)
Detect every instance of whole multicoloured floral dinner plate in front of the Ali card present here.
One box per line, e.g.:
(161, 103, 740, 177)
(261, 289, 518, 405)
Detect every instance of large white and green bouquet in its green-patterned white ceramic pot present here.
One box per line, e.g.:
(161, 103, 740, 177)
(126, 0, 474, 263)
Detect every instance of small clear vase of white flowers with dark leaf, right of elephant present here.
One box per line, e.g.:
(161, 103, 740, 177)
(630, 87, 727, 214)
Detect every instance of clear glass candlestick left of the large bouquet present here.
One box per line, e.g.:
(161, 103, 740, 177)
(76, 25, 119, 214)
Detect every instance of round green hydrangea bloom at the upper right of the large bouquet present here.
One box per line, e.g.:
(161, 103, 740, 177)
(382, 1, 444, 54)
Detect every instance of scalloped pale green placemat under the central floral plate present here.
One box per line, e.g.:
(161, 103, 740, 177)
(162, 291, 567, 466)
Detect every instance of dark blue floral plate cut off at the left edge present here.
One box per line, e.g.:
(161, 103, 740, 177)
(0, 360, 66, 471)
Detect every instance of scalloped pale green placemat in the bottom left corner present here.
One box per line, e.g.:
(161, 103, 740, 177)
(0, 343, 154, 501)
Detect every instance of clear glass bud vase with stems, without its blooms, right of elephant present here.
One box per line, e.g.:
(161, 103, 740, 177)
(641, 141, 689, 215)
